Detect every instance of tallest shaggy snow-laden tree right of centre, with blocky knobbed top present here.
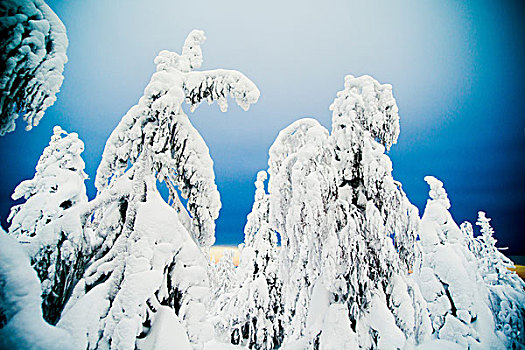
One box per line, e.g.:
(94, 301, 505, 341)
(328, 75, 428, 348)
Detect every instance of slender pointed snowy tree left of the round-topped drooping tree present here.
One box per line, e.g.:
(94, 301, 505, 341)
(216, 171, 283, 349)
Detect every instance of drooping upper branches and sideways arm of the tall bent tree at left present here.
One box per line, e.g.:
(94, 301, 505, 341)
(95, 30, 259, 248)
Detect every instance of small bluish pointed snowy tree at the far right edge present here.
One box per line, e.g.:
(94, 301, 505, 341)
(476, 211, 525, 349)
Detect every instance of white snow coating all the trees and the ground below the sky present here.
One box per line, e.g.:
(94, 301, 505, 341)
(0, 27, 525, 350)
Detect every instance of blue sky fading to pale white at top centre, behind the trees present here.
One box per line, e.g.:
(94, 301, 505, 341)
(0, 0, 525, 254)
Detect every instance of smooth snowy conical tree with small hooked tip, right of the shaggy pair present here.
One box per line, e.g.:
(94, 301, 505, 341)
(417, 176, 503, 349)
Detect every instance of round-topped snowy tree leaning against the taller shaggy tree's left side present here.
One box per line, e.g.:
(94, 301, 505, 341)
(268, 119, 336, 341)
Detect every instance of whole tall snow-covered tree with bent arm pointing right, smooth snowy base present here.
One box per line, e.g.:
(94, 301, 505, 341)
(59, 30, 259, 349)
